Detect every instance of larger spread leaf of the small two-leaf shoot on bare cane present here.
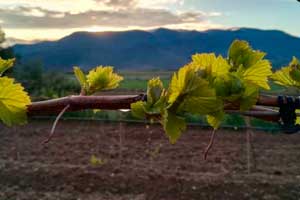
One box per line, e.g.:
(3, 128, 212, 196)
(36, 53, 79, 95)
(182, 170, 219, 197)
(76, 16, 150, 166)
(87, 66, 123, 94)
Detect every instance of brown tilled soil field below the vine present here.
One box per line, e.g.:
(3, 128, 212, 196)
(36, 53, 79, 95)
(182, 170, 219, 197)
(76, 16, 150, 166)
(0, 121, 300, 200)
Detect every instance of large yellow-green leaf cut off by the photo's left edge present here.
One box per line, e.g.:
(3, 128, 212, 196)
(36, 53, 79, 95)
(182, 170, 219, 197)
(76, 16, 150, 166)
(0, 77, 31, 126)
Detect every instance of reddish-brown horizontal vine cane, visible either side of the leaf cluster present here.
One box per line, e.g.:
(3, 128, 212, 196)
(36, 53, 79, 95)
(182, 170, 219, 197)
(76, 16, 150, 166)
(28, 94, 288, 121)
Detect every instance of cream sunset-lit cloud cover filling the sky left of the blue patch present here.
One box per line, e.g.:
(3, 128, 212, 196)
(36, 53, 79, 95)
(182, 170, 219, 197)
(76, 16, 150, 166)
(0, 0, 221, 40)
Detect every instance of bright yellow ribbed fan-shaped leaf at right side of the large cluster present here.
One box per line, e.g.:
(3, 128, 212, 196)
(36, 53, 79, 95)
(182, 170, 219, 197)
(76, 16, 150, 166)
(238, 60, 272, 90)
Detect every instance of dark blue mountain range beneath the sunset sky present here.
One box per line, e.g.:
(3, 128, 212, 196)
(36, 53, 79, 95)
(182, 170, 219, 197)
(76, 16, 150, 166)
(14, 28, 300, 70)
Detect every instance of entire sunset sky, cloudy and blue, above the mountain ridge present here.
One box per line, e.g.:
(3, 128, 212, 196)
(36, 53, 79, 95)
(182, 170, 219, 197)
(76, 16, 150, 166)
(0, 0, 300, 41)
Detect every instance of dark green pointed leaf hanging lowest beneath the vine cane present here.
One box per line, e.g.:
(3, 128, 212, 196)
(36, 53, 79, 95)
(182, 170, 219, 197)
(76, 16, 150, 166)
(161, 112, 186, 144)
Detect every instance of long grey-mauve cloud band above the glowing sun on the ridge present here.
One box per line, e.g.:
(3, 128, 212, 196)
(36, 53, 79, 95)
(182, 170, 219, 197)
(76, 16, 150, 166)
(0, 6, 219, 29)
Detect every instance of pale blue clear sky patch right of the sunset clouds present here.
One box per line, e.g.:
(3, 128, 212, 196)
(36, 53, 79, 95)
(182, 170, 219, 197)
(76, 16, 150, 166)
(184, 0, 300, 36)
